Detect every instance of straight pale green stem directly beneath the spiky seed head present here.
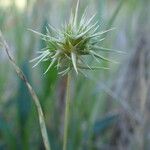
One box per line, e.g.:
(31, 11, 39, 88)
(63, 73, 71, 150)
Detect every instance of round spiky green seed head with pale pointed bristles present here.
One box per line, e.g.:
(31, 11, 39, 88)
(31, 0, 120, 75)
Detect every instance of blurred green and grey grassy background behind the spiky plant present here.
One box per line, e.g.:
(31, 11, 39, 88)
(0, 0, 150, 150)
